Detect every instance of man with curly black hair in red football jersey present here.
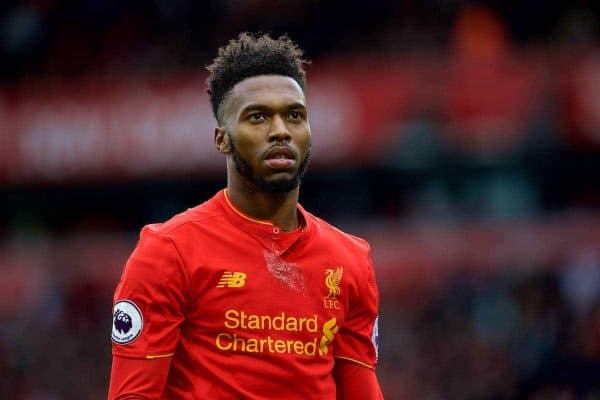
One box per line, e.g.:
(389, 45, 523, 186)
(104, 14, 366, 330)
(109, 34, 382, 400)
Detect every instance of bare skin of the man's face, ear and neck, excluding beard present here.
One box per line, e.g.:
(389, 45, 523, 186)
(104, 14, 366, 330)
(214, 75, 311, 231)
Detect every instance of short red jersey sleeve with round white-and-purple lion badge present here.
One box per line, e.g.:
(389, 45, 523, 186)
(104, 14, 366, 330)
(111, 226, 187, 359)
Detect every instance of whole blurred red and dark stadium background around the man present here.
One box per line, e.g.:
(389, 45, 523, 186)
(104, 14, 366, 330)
(0, 0, 600, 400)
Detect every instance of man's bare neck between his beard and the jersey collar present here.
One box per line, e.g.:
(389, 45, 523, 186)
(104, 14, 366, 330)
(227, 177, 300, 232)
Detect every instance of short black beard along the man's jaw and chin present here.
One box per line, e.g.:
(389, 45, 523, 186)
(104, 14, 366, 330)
(229, 137, 310, 193)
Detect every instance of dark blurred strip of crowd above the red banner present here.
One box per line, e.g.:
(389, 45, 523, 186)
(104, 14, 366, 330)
(0, 0, 600, 82)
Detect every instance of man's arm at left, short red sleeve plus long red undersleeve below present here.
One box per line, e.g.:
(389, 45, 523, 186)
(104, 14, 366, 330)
(110, 228, 187, 399)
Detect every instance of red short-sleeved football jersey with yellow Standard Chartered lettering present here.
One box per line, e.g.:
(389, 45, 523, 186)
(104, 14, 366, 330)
(112, 190, 379, 400)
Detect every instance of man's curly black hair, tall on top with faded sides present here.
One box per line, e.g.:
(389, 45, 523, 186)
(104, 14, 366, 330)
(206, 32, 309, 123)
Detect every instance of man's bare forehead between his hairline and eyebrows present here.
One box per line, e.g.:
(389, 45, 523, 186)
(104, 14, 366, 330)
(230, 75, 305, 113)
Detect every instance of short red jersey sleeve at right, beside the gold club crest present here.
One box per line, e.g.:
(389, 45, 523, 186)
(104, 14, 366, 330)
(334, 250, 379, 368)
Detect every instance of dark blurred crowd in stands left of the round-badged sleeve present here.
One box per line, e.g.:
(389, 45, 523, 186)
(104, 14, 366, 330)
(0, 265, 113, 400)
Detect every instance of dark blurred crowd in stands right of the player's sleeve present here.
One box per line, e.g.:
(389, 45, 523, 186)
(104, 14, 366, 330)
(381, 249, 600, 399)
